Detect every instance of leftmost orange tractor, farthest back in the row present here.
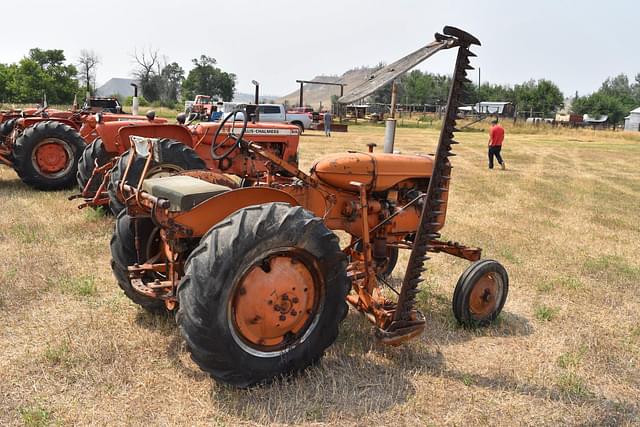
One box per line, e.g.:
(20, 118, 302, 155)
(0, 107, 165, 190)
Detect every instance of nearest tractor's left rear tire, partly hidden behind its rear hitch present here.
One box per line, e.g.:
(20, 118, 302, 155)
(111, 211, 167, 314)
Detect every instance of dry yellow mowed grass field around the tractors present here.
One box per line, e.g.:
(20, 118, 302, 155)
(0, 126, 640, 425)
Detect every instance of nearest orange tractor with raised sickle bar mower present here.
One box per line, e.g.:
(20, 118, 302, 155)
(111, 27, 508, 387)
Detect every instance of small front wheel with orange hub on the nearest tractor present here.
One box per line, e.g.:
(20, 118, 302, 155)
(453, 259, 509, 326)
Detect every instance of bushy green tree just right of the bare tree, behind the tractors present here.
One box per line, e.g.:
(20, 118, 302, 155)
(182, 55, 236, 101)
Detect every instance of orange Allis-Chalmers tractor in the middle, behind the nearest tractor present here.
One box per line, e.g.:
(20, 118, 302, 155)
(76, 114, 300, 214)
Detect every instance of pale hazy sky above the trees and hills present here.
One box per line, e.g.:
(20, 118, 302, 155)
(0, 0, 640, 95)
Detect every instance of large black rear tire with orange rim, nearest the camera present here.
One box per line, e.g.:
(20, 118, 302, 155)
(177, 203, 350, 387)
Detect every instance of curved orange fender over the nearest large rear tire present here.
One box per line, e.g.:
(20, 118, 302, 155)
(174, 187, 299, 237)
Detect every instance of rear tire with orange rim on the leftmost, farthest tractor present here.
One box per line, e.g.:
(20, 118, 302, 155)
(13, 121, 85, 191)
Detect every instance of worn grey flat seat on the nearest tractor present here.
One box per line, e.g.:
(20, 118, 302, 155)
(142, 175, 230, 212)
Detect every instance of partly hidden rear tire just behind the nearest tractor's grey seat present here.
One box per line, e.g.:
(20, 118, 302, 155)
(107, 138, 206, 215)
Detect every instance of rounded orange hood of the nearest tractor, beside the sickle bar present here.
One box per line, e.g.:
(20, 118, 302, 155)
(311, 153, 433, 191)
